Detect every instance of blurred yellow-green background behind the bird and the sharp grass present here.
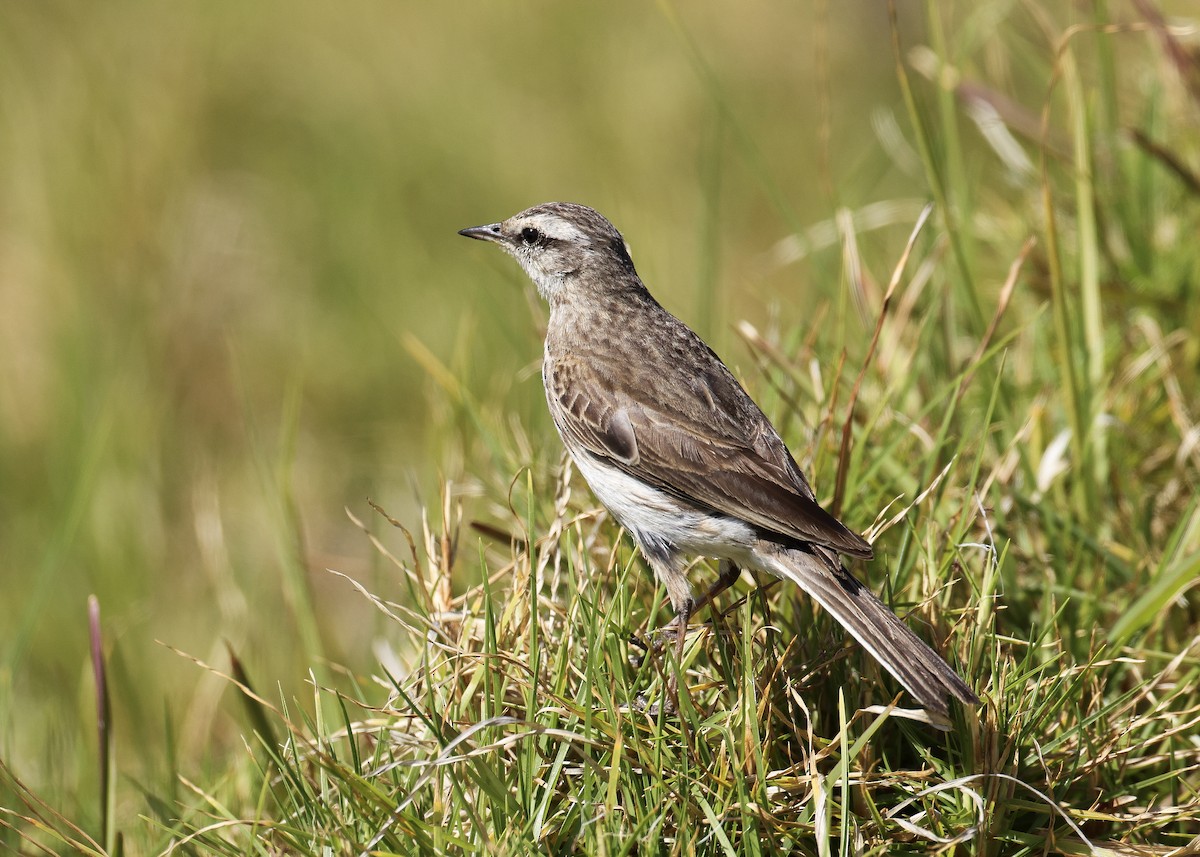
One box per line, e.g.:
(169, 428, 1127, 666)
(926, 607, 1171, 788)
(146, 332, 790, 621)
(0, 0, 1195, 825)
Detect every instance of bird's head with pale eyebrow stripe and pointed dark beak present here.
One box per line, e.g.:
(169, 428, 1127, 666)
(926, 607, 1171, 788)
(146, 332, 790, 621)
(458, 203, 644, 302)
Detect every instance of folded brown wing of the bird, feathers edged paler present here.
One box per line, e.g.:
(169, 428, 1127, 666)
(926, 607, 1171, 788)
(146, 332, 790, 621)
(545, 337, 871, 557)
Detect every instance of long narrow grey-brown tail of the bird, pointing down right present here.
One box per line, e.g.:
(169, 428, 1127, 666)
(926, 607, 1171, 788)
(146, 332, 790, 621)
(760, 546, 979, 718)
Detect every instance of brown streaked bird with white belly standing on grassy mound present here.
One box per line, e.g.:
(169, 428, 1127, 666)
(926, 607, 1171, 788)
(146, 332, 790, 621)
(458, 202, 979, 715)
